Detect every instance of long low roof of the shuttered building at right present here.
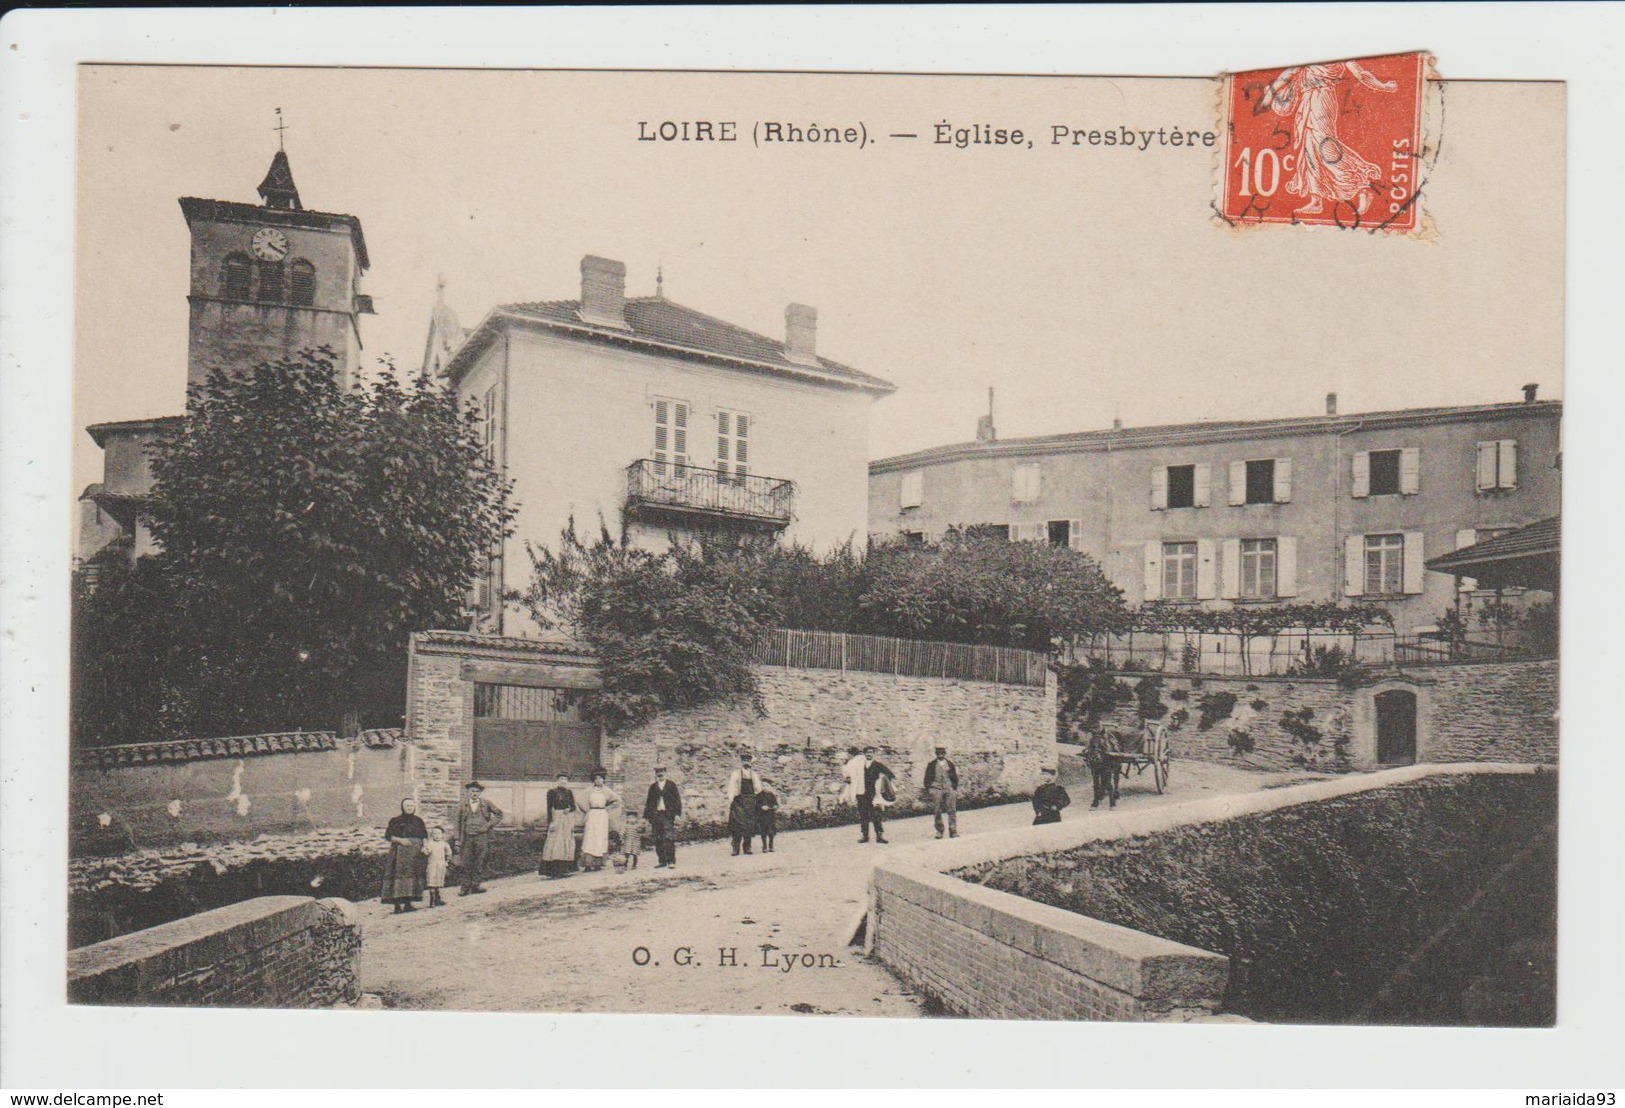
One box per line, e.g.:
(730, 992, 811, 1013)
(869, 400, 1563, 473)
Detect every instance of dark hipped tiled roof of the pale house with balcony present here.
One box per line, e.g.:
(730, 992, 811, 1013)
(447, 296, 897, 395)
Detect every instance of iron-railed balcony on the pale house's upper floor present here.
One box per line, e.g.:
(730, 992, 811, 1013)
(626, 458, 796, 531)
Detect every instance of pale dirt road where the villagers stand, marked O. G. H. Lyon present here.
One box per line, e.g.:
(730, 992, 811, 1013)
(361, 762, 1307, 1017)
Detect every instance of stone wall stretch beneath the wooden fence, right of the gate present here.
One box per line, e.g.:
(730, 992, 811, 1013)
(605, 666, 1056, 820)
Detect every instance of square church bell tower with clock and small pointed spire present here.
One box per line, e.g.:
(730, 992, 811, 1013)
(180, 138, 372, 388)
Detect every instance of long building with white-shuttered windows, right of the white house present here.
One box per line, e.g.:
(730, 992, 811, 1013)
(869, 385, 1562, 634)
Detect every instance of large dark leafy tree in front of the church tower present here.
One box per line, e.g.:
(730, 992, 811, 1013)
(80, 349, 514, 741)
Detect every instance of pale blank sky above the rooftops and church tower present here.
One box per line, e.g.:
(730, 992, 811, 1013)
(73, 67, 1563, 492)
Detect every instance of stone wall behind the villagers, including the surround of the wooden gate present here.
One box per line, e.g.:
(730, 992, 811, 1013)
(408, 632, 1056, 824)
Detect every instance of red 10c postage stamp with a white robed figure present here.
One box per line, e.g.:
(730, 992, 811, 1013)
(1220, 54, 1427, 232)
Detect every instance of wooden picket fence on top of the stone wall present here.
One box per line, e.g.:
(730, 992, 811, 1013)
(756, 629, 1050, 689)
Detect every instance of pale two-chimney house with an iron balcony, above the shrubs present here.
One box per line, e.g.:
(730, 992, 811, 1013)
(424, 257, 894, 634)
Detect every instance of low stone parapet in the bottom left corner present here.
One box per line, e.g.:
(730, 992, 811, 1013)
(68, 897, 361, 1007)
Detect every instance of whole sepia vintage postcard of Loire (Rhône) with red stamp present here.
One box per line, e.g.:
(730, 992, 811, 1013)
(62, 54, 1567, 1033)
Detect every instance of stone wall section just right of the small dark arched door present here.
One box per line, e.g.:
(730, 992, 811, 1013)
(1417, 658, 1558, 762)
